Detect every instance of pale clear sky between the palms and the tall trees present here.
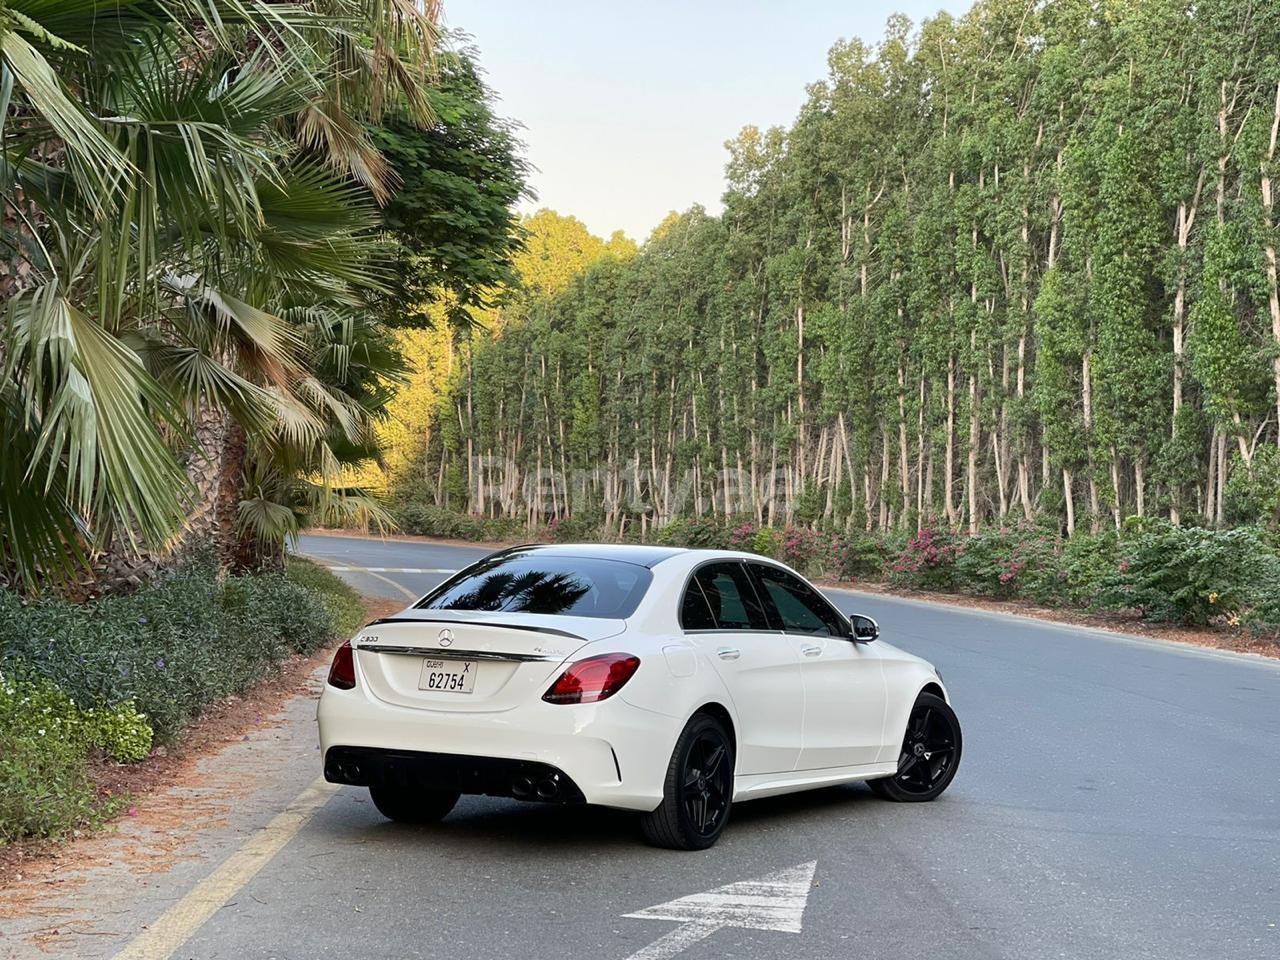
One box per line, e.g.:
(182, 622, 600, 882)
(444, 0, 970, 241)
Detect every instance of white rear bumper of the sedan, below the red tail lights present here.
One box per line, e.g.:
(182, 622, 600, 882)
(316, 686, 678, 810)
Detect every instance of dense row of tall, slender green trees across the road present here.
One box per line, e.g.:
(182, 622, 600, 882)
(401, 0, 1280, 534)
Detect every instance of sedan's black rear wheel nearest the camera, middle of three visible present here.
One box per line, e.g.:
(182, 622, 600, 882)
(640, 713, 735, 850)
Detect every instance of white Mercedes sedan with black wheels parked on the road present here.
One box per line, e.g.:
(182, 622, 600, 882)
(319, 544, 960, 850)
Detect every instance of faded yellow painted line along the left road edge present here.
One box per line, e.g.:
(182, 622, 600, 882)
(114, 780, 338, 960)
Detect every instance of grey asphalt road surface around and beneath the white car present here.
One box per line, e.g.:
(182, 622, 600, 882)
(175, 536, 1280, 960)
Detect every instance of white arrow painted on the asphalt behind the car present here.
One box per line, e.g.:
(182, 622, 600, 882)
(623, 860, 818, 960)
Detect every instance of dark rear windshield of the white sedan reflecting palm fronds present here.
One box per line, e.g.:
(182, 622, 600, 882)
(417, 553, 653, 620)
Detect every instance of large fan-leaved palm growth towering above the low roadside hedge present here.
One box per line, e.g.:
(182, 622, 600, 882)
(0, 0, 435, 588)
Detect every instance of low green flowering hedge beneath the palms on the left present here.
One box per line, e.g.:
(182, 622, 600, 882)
(0, 559, 364, 842)
